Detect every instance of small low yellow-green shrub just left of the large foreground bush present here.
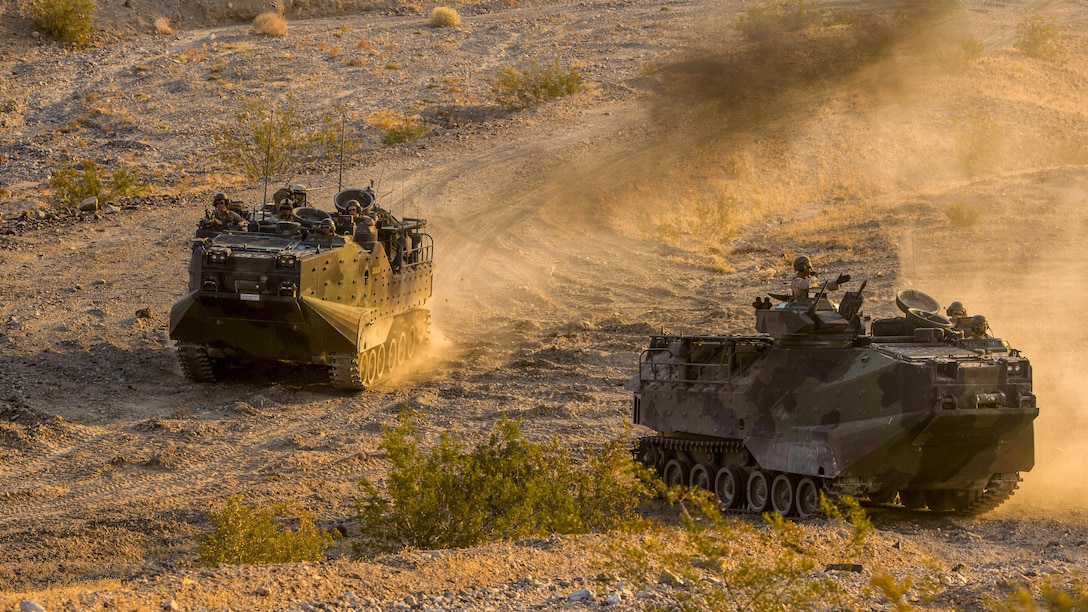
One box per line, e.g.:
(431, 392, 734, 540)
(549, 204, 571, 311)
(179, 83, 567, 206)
(197, 495, 333, 565)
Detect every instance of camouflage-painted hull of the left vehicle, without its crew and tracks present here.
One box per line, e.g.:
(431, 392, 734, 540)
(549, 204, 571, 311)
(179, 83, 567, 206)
(170, 192, 433, 387)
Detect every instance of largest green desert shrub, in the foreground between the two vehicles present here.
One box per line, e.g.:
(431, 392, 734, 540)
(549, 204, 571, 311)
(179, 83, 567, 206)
(356, 409, 643, 553)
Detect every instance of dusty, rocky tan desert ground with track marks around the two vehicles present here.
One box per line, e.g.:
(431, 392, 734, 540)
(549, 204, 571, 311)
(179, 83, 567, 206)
(0, 0, 1088, 610)
